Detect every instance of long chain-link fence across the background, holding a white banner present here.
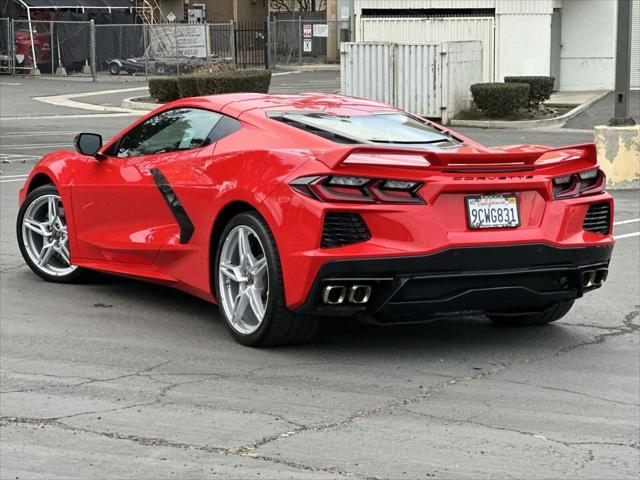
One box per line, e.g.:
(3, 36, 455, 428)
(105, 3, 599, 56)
(0, 18, 351, 79)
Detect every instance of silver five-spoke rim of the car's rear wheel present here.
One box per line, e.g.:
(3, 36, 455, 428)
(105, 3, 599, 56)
(218, 225, 269, 335)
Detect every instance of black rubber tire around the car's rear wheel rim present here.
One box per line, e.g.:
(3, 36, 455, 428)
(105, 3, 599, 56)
(213, 211, 319, 347)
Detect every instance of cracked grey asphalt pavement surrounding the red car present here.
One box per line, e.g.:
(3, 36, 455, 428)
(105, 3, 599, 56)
(0, 74, 640, 479)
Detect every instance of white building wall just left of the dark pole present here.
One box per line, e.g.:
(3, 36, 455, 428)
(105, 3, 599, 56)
(560, 0, 616, 90)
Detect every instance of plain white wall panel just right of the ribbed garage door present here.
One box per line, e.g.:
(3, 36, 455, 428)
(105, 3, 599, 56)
(496, 14, 551, 82)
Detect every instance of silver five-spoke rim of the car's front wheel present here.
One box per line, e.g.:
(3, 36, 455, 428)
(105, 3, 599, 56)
(22, 194, 77, 277)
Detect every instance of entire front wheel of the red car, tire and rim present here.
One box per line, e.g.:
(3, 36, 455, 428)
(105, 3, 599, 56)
(16, 185, 85, 283)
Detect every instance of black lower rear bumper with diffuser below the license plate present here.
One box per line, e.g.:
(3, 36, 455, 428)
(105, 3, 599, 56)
(297, 244, 613, 322)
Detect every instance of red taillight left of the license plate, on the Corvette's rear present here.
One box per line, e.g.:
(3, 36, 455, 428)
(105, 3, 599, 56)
(289, 175, 424, 204)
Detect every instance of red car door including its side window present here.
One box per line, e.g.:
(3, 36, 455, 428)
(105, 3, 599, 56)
(72, 108, 221, 265)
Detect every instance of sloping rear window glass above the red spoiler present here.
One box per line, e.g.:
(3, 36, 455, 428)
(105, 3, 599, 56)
(276, 112, 458, 146)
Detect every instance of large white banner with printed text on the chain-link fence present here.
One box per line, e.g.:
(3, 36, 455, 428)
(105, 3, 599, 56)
(151, 24, 207, 58)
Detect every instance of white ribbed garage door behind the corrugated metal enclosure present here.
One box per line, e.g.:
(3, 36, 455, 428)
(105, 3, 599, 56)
(358, 17, 495, 82)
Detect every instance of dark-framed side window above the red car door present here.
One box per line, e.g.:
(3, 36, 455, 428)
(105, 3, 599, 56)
(112, 108, 223, 157)
